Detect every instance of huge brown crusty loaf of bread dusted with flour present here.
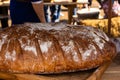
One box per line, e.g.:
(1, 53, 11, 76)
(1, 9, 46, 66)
(0, 23, 116, 74)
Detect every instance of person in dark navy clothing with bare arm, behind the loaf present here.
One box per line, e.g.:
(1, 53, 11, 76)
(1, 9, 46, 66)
(10, 0, 46, 24)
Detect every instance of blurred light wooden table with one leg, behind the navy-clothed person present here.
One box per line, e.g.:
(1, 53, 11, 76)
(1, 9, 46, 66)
(0, 2, 88, 24)
